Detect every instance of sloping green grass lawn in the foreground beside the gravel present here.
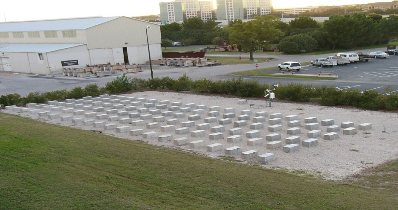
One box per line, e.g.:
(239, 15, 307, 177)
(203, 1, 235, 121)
(0, 114, 398, 209)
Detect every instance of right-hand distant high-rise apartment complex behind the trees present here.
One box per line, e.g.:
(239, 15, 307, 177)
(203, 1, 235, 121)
(217, 0, 272, 21)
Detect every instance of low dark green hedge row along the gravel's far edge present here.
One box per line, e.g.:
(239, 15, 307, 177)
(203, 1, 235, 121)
(0, 75, 398, 111)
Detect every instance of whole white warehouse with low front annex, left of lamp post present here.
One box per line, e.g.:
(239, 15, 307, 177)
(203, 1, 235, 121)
(0, 17, 162, 74)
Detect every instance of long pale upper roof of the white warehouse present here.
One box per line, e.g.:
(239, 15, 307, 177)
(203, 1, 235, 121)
(0, 17, 119, 32)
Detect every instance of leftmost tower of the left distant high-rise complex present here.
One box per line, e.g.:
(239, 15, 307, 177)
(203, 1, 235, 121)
(159, 2, 183, 24)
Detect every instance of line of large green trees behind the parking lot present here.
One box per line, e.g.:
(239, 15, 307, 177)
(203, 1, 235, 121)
(161, 14, 398, 55)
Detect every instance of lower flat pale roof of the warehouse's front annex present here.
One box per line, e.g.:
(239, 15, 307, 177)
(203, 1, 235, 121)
(0, 44, 84, 53)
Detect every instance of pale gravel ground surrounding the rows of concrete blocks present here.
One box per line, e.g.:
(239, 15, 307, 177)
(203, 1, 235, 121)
(5, 91, 398, 180)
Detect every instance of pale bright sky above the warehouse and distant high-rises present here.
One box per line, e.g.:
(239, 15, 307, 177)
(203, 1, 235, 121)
(0, 0, 392, 22)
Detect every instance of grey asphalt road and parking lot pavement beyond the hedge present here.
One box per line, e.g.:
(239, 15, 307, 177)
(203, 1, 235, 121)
(0, 48, 398, 95)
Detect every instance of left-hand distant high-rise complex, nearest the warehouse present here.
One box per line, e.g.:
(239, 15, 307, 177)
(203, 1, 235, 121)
(159, 0, 214, 24)
